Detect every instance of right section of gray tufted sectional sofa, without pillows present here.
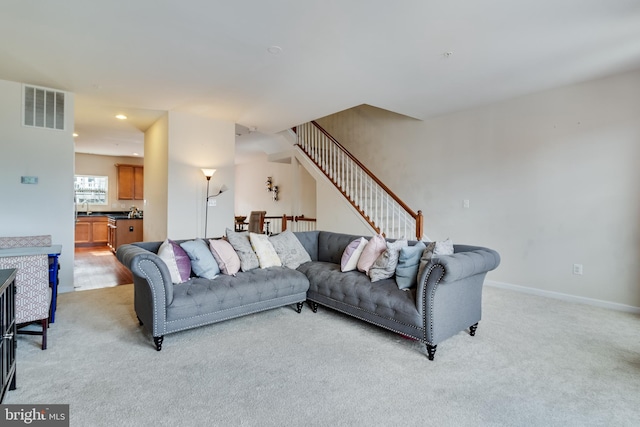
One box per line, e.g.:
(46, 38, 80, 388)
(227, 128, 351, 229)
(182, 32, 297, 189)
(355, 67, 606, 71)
(298, 231, 500, 360)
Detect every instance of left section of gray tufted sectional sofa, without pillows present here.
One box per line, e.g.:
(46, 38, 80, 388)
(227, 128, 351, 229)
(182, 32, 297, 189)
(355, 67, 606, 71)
(116, 241, 309, 351)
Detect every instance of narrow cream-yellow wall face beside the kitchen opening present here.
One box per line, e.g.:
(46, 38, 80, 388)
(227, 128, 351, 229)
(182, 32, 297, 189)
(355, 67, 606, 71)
(143, 113, 169, 242)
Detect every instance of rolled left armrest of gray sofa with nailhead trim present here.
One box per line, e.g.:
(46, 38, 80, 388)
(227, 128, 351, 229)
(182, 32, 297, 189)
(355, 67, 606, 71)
(116, 244, 173, 307)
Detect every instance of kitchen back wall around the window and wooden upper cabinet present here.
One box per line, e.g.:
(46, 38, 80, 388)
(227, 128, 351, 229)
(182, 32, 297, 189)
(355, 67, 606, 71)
(75, 153, 144, 212)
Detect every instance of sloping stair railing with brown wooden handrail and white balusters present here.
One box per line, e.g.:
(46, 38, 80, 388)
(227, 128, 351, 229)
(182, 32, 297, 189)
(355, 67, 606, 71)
(295, 121, 423, 240)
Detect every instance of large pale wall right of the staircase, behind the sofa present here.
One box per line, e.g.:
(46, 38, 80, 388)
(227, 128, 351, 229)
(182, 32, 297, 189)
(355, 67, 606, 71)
(318, 72, 640, 307)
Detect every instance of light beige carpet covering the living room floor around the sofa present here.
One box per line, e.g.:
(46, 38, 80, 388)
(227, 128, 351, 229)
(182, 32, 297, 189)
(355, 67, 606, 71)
(4, 285, 640, 426)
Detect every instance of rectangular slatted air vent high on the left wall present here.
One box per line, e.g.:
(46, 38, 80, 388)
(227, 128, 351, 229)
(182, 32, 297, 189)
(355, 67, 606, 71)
(22, 85, 65, 130)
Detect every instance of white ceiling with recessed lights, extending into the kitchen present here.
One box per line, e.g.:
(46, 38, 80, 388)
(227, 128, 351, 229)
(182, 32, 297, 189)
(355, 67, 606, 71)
(0, 0, 640, 155)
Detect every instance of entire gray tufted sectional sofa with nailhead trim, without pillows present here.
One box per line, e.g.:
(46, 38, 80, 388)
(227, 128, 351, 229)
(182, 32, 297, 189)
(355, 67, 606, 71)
(117, 231, 500, 360)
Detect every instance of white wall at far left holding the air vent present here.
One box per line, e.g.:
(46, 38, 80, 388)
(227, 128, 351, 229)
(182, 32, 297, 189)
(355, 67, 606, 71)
(0, 80, 74, 292)
